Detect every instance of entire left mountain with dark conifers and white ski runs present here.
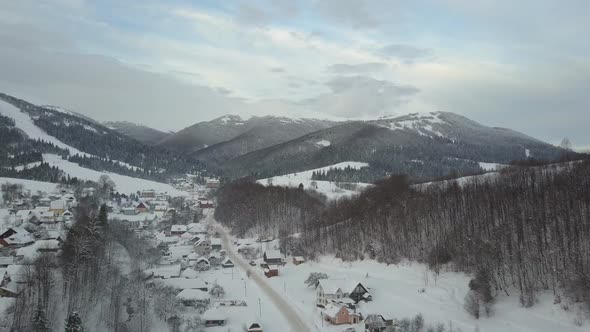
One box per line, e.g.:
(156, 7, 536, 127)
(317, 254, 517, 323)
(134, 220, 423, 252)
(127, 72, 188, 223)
(0, 94, 210, 189)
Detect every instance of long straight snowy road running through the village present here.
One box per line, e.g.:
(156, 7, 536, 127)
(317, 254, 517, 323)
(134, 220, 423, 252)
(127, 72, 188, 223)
(212, 222, 312, 332)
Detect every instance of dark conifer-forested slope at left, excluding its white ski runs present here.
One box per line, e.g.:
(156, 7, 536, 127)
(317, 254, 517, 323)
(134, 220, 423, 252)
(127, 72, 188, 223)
(0, 94, 213, 181)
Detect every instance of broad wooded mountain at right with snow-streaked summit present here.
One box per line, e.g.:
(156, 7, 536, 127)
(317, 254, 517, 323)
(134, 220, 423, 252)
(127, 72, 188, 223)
(225, 112, 562, 182)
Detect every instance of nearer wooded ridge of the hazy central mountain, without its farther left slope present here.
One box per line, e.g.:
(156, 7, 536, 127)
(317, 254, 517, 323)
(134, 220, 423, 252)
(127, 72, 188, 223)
(194, 116, 335, 164)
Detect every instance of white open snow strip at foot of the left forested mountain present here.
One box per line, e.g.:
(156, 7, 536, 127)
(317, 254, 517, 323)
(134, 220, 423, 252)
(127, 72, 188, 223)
(43, 154, 188, 196)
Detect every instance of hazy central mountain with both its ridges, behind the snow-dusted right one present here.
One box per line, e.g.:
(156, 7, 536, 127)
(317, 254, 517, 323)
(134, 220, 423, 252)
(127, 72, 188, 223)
(159, 115, 333, 154)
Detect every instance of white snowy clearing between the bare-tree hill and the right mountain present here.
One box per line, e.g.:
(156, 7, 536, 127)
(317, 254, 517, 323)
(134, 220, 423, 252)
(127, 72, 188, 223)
(258, 161, 370, 199)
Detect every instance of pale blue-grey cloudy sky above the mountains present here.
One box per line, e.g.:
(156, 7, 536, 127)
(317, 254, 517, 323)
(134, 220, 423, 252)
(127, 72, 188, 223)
(0, 0, 590, 147)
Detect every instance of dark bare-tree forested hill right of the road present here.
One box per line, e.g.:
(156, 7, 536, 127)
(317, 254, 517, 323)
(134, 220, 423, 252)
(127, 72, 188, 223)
(216, 160, 590, 312)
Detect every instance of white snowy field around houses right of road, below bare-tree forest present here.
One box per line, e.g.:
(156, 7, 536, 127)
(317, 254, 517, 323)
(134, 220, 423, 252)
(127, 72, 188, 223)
(256, 257, 590, 332)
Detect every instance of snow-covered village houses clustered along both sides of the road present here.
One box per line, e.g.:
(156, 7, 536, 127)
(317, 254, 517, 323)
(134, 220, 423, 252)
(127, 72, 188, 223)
(0, 172, 402, 332)
